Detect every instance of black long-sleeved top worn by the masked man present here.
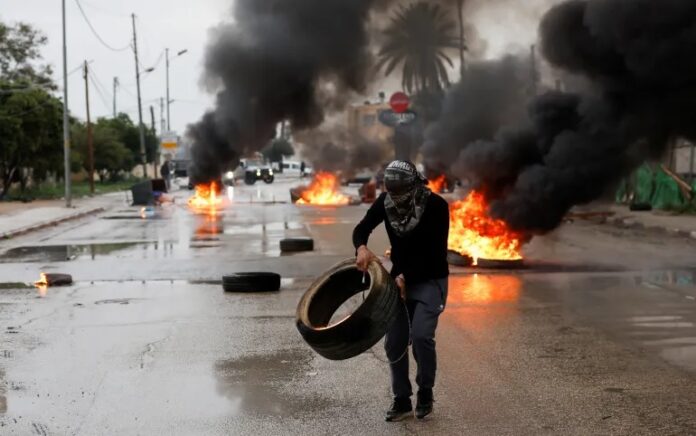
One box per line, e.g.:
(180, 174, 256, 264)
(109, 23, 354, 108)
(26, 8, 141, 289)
(353, 193, 449, 283)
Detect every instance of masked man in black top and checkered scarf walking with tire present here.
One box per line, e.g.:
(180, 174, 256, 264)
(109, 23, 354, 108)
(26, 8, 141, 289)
(353, 161, 449, 421)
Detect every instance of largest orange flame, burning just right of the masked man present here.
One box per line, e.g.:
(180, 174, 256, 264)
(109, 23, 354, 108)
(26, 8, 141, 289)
(447, 191, 524, 265)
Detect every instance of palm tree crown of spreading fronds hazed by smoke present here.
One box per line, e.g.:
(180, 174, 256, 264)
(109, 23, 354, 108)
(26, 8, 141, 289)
(377, 1, 462, 93)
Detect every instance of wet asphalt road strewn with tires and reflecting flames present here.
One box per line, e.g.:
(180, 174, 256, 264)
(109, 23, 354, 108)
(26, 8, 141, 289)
(0, 181, 696, 435)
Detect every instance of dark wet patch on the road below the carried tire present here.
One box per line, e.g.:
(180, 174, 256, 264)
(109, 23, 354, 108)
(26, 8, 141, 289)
(214, 350, 331, 416)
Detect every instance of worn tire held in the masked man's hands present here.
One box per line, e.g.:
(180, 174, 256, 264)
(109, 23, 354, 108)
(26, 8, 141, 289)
(296, 259, 401, 360)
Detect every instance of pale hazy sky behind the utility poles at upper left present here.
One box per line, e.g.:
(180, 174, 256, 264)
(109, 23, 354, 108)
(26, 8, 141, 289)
(0, 0, 231, 136)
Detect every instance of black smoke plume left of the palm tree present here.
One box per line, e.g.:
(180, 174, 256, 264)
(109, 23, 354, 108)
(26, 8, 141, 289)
(188, 0, 388, 183)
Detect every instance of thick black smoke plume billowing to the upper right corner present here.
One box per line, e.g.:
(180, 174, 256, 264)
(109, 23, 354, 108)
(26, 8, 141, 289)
(429, 0, 696, 233)
